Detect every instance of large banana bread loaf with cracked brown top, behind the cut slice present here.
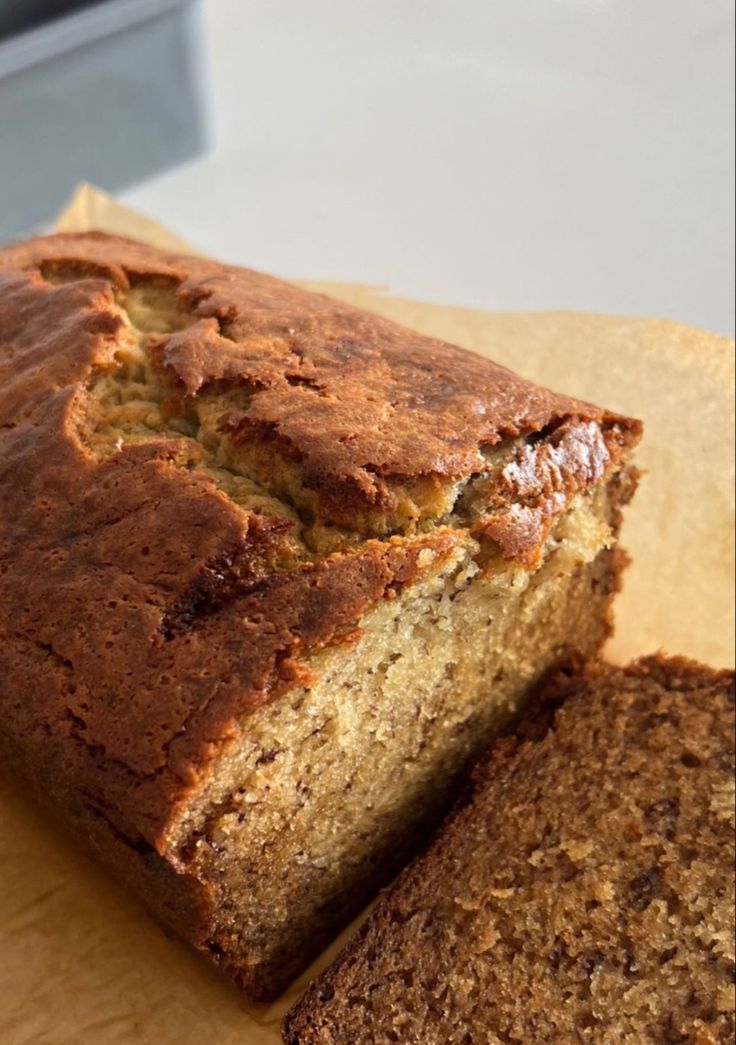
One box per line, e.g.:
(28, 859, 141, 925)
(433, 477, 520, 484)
(0, 233, 639, 998)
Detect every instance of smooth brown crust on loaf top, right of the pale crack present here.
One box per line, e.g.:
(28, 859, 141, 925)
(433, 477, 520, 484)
(0, 233, 638, 526)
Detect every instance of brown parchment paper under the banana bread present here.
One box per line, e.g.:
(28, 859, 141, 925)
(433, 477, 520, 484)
(0, 186, 734, 1045)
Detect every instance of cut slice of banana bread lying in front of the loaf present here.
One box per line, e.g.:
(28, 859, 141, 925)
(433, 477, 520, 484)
(283, 657, 735, 1045)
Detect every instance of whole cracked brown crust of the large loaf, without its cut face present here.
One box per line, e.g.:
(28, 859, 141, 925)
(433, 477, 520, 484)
(0, 233, 639, 851)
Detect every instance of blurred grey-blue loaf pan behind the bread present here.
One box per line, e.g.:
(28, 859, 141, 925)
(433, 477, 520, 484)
(0, 0, 205, 241)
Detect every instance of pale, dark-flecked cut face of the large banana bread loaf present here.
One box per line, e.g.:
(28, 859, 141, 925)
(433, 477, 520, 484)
(171, 479, 624, 998)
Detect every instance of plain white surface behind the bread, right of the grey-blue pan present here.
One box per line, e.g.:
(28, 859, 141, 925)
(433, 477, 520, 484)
(124, 0, 734, 332)
